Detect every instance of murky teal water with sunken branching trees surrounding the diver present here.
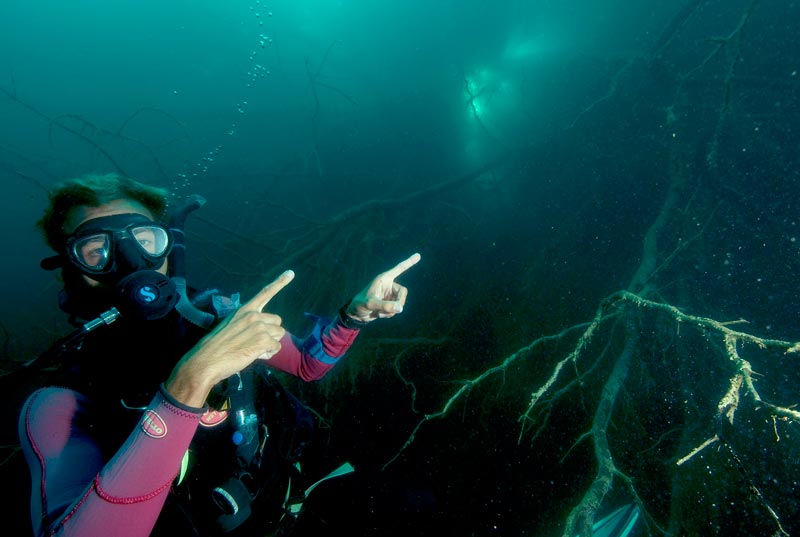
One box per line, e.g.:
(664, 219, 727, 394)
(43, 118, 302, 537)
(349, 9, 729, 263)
(0, 0, 800, 537)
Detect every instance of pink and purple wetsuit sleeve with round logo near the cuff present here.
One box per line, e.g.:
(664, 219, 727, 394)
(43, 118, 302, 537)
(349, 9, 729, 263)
(19, 387, 202, 537)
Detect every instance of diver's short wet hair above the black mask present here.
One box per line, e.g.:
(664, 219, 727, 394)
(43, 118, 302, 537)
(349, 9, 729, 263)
(37, 173, 169, 252)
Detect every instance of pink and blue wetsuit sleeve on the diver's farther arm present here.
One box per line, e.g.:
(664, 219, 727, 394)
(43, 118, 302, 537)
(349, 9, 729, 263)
(266, 315, 359, 381)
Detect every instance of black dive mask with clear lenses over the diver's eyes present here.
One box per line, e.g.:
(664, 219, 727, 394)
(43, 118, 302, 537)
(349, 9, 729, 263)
(66, 213, 173, 285)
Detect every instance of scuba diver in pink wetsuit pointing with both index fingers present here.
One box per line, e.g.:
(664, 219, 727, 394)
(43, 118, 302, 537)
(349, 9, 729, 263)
(18, 174, 420, 537)
